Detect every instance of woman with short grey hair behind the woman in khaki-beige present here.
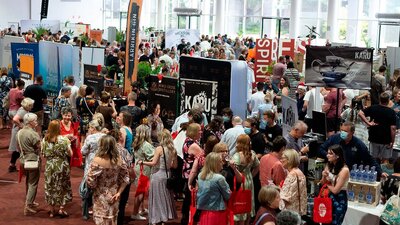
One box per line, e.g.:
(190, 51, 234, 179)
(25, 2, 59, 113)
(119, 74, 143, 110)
(8, 98, 35, 173)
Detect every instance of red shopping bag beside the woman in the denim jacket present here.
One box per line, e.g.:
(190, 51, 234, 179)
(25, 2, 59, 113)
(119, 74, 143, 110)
(228, 176, 252, 215)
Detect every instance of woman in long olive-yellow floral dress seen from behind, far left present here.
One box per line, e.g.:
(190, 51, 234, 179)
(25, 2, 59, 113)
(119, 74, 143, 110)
(42, 120, 72, 217)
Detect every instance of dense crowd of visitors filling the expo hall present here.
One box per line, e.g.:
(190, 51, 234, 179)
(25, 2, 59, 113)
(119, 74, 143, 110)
(0, 28, 400, 225)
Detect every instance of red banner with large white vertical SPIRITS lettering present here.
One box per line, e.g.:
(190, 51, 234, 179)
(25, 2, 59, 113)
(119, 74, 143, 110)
(254, 38, 307, 82)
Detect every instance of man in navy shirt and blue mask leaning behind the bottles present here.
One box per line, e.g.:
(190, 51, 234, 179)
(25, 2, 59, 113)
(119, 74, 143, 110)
(318, 122, 387, 177)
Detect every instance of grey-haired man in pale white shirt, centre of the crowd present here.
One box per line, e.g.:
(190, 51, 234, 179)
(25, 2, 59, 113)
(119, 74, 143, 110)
(221, 116, 244, 156)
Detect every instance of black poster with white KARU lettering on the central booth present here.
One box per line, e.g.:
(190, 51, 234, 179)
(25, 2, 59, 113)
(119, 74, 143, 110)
(180, 78, 218, 121)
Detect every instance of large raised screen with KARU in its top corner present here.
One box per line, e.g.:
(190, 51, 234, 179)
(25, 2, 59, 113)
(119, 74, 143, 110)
(305, 46, 373, 89)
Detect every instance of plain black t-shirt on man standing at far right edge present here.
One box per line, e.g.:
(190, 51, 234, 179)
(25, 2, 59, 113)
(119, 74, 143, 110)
(363, 105, 396, 144)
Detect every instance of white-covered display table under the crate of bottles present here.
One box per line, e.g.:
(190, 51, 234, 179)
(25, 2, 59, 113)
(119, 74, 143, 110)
(343, 202, 384, 225)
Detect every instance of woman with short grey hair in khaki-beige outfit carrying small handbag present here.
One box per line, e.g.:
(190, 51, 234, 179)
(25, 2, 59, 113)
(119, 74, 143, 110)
(16, 113, 40, 215)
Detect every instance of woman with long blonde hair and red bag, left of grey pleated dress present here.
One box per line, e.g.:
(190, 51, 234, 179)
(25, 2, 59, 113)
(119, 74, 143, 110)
(131, 124, 154, 220)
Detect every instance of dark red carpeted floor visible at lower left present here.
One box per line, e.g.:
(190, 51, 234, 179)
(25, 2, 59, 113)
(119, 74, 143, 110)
(0, 129, 181, 225)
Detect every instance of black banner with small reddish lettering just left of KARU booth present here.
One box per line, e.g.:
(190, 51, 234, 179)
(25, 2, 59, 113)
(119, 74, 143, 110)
(149, 75, 179, 129)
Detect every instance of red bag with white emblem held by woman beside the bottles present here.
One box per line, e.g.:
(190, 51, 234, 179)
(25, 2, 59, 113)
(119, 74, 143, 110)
(313, 184, 332, 223)
